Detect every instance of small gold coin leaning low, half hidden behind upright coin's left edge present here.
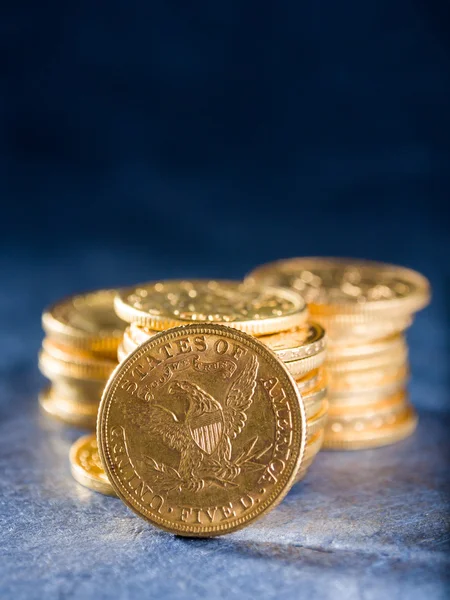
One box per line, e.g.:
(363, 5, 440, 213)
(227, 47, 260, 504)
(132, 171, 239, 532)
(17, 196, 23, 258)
(69, 433, 116, 496)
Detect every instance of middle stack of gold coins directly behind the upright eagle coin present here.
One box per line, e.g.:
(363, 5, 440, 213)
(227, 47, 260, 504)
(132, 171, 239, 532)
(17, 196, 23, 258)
(115, 281, 328, 481)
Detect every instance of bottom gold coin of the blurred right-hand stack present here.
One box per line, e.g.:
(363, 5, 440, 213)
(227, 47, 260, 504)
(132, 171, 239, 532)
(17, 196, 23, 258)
(323, 405, 418, 450)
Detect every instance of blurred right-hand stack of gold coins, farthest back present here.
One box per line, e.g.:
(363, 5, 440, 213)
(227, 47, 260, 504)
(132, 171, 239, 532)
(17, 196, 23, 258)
(247, 258, 430, 449)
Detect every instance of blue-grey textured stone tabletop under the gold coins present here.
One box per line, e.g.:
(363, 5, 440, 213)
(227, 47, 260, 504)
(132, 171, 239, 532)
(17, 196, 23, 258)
(0, 248, 450, 600)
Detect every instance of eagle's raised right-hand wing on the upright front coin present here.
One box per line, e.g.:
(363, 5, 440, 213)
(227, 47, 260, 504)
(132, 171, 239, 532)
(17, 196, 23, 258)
(223, 356, 258, 438)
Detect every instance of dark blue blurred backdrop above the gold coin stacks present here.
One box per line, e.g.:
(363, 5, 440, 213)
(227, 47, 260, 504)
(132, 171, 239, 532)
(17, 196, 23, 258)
(0, 0, 450, 406)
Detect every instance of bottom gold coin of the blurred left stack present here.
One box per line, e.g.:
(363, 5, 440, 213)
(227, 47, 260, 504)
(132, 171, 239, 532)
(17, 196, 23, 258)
(39, 386, 98, 429)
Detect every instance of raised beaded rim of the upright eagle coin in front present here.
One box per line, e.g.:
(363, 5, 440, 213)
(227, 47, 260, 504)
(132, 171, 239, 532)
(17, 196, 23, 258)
(97, 323, 307, 537)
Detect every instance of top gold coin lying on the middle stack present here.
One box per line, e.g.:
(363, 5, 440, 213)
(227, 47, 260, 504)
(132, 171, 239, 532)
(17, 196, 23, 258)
(114, 280, 308, 335)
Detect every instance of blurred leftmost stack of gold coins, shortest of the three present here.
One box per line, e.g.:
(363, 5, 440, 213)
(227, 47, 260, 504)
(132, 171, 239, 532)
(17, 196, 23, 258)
(39, 290, 124, 429)
